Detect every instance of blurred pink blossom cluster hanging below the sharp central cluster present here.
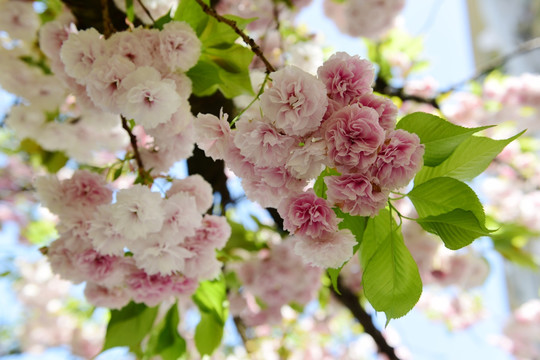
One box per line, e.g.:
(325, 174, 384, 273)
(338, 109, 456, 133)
(231, 241, 322, 326)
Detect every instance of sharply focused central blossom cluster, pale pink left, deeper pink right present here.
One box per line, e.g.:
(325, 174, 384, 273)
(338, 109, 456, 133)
(195, 52, 424, 267)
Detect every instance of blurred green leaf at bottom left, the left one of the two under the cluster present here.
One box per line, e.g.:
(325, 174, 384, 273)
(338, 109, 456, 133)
(102, 302, 158, 356)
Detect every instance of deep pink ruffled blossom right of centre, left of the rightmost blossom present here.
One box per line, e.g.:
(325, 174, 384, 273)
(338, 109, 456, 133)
(324, 104, 385, 172)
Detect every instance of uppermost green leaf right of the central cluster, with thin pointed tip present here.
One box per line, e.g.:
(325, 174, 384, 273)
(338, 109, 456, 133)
(396, 112, 491, 166)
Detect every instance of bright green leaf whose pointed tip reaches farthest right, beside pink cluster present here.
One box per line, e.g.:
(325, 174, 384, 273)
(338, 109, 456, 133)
(414, 131, 525, 184)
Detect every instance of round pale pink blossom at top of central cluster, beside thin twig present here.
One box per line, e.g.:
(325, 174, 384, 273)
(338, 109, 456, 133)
(261, 66, 328, 136)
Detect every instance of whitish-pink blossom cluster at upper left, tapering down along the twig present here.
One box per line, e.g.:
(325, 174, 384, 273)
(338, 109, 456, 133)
(39, 21, 201, 172)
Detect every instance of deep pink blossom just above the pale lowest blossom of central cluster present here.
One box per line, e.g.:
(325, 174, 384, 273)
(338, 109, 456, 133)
(278, 190, 338, 238)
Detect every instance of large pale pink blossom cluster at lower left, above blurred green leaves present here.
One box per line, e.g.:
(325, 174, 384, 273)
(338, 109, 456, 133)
(36, 171, 231, 308)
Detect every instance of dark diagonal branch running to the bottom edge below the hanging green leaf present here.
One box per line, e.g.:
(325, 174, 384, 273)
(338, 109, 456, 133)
(330, 276, 399, 360)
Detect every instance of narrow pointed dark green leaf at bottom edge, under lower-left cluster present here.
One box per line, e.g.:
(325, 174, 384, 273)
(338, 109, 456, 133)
(147, 303, 186, 360)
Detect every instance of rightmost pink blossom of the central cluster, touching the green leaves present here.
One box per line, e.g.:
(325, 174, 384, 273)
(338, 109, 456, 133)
(371, 129, 424, 190)
